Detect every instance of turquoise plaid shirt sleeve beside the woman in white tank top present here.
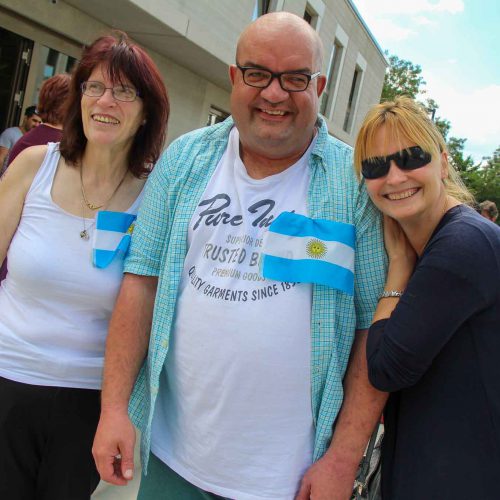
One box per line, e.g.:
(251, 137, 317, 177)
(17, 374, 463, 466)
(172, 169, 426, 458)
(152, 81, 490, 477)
(124, 145, 175, 276)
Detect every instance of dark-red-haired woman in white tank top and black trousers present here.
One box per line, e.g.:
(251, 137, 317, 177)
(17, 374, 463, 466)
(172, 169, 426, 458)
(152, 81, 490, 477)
(0, 33, 169, 500)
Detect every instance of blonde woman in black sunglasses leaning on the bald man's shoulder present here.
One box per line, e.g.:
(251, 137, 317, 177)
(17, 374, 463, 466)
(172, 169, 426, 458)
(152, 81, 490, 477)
(355, 98, 500, 500)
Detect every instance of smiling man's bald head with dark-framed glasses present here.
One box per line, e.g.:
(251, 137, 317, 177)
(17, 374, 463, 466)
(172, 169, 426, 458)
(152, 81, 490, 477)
(229, 12, 326, 170)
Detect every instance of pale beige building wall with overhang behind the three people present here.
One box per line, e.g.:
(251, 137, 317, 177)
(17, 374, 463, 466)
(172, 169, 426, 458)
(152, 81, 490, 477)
(0, 0, 387, 145)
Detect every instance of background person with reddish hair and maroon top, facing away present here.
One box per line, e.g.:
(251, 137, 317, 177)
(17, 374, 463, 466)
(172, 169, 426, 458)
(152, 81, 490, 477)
(7, 73, 71, 167)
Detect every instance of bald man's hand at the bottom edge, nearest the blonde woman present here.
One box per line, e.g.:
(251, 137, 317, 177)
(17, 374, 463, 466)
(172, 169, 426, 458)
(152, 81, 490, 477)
(296, 453, 358, 500)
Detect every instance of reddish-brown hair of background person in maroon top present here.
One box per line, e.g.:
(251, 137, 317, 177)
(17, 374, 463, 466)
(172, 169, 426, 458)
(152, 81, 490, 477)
(37, 73, 71, 125)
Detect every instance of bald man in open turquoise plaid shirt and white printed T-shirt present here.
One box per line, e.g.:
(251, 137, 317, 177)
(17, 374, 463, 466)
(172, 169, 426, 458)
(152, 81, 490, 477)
(94, 13, 385, 500)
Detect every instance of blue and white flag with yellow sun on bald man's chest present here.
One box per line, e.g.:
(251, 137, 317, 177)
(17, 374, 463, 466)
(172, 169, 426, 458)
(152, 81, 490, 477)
(262, 212, 356, 295)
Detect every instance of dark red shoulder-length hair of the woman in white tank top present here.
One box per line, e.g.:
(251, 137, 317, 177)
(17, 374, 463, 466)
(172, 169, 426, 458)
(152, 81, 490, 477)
(60, 31, 170, 177)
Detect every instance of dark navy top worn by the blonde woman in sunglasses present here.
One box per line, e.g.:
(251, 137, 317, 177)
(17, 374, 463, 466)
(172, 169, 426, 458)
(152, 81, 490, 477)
(367, 205, 500, 500)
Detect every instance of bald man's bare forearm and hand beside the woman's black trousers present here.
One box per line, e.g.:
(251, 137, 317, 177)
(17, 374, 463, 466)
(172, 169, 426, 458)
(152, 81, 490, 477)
(92, 274, 158, 486)
